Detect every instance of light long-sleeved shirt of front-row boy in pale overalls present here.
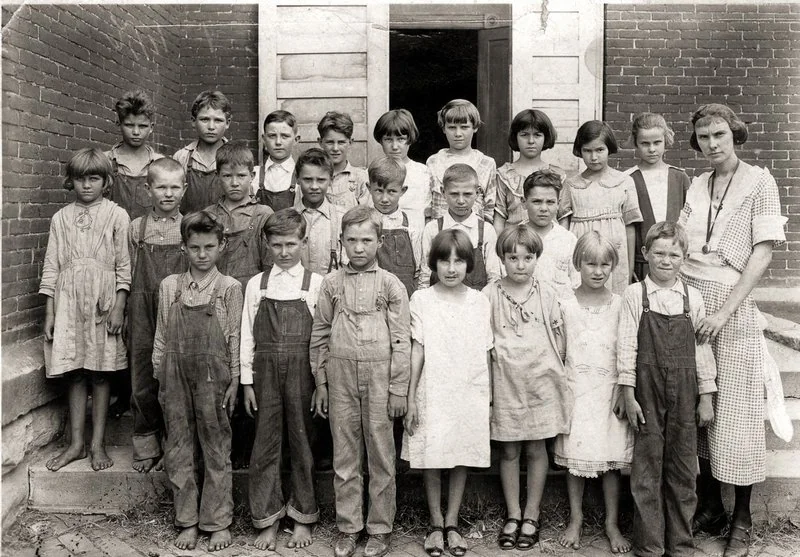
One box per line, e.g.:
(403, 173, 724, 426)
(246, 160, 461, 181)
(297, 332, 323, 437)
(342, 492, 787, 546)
(309, 262, 411, 396)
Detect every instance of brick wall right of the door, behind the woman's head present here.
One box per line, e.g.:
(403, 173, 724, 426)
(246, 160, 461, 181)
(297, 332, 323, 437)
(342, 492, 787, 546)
(604, 3, 800, 286)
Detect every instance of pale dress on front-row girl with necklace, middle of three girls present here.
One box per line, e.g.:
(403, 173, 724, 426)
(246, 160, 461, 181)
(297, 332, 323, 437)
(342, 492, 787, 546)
(483, 281, 573, 442)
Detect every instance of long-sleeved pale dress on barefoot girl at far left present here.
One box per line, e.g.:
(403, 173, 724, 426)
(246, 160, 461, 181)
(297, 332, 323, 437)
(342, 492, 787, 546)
(39, 198, 131, 377)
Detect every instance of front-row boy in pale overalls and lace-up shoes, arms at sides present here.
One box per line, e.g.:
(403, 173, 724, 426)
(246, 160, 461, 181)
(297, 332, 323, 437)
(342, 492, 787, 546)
(310, 206, 411, 557)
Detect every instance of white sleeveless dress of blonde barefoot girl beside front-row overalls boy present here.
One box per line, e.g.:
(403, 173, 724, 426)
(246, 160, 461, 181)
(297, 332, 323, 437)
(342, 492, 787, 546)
(555, 294, 633, 478)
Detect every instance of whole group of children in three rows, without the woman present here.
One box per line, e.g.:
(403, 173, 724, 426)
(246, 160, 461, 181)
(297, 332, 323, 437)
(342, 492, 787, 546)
(40, 91, 715, 557)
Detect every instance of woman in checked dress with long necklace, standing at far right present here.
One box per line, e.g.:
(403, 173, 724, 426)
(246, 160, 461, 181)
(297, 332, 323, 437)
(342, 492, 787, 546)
(678, 104, 792, 557)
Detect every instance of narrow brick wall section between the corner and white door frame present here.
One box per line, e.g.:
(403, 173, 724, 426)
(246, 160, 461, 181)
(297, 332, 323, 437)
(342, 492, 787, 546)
(179, 4, 260, 153)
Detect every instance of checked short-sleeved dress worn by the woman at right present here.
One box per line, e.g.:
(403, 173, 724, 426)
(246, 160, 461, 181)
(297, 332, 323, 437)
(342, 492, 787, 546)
(678, 161, 787, 485)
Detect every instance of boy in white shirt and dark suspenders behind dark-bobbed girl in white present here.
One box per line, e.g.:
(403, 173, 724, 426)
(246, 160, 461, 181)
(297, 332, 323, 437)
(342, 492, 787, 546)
(419, 163, 500, 290)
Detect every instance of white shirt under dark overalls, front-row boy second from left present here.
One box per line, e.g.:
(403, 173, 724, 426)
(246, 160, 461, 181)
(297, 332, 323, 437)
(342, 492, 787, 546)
(239, 263, 322, 385)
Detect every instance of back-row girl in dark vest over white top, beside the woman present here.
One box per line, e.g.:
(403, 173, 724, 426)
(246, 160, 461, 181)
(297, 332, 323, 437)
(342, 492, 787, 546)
(627, 112, 691, 281)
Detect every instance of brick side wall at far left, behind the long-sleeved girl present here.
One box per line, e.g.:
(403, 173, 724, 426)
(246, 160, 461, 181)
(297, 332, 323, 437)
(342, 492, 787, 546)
(2, 4, 182, 345)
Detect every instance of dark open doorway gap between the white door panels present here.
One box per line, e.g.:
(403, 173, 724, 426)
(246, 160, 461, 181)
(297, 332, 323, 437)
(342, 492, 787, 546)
(389, 29, 480, 163)
